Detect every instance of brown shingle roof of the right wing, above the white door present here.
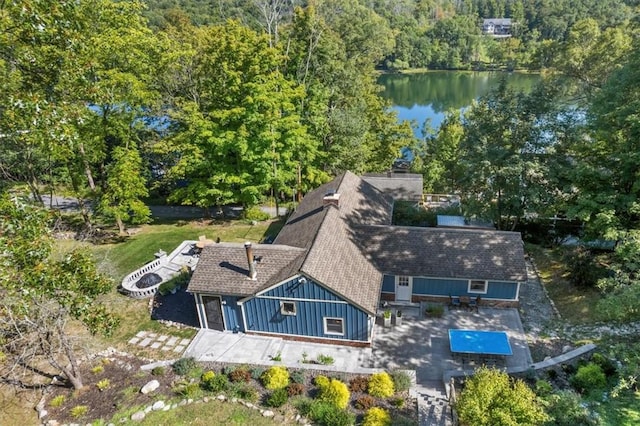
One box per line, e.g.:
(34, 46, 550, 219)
(354, 226, 527, 281)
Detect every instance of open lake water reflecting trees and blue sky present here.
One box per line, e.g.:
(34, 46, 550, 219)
(378, 71, 540, 137)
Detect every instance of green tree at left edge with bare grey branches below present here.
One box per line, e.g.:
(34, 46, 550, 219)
(0, 193, 119, 389)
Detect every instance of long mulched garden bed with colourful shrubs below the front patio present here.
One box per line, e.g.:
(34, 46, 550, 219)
(42, 354, 418, 424)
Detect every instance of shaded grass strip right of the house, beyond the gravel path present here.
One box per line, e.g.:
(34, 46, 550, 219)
(526, 244, 601, 324)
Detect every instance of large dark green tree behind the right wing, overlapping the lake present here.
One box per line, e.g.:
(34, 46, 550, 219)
(459, 81, 555, 230)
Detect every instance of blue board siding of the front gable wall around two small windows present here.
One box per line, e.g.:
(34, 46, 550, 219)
(242, 280, 368, 341)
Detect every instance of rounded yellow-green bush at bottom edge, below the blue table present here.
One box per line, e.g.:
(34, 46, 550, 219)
(455, 367, 547, 426)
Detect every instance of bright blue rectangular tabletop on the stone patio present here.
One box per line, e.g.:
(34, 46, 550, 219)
(449, 330, 513, 356)
